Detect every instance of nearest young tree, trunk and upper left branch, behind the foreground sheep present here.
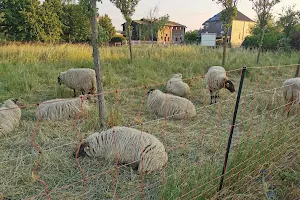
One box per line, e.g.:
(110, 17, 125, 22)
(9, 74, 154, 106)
(80, 0, 106, 128)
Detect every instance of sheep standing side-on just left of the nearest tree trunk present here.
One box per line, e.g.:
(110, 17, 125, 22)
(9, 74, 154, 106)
(57, 68, 97, 97)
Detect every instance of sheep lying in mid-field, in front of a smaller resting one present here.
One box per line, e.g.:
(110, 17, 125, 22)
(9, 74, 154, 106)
(147, 89, 196, 119)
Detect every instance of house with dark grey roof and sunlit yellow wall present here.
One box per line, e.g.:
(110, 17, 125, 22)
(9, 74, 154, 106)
(200, 11, 255, 47)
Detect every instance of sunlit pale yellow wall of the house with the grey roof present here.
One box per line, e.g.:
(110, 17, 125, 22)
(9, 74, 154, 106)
(230, 20, 255, 47)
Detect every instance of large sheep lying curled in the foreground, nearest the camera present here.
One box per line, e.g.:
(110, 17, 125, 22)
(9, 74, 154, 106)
(73, 126, 168, 173)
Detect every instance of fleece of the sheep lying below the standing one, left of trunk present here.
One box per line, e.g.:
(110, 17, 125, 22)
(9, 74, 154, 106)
(35, 97, 88, 120)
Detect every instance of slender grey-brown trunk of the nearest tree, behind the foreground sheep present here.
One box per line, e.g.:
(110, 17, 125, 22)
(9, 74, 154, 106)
(91, 0, 105, 127)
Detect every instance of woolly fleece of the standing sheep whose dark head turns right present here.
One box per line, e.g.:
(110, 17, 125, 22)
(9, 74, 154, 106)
(205, 66, 228, 92)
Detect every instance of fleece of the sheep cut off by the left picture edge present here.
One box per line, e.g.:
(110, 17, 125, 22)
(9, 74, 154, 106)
(0, 99, 21, 136)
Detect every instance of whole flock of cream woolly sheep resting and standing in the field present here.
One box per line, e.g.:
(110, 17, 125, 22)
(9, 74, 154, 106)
(0, 66, 300, 173)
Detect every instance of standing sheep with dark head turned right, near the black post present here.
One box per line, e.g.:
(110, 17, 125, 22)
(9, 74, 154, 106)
(205, 66, 235, 104)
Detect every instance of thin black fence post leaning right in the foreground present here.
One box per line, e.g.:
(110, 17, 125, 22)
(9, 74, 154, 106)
(218, 67, 246, 196)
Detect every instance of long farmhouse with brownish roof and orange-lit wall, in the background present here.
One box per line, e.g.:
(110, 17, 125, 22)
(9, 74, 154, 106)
(122, 18, 186, 44)
